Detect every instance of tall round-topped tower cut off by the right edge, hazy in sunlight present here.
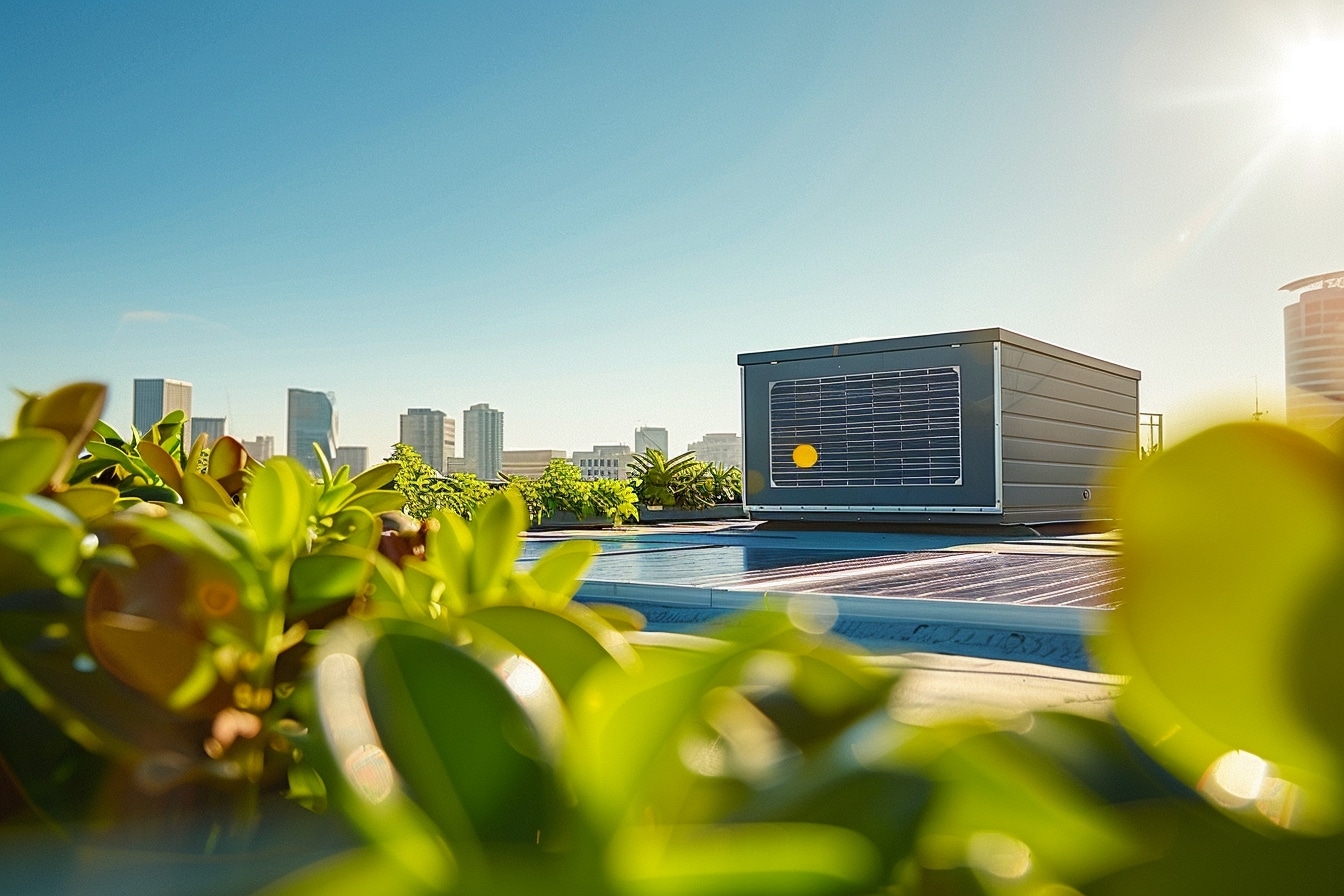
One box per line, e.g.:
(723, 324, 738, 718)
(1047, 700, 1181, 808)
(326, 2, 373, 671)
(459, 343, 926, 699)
(1279, 270, 1344, 430)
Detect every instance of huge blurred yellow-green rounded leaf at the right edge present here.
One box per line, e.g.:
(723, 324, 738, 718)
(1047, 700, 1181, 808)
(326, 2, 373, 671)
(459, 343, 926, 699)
(1095, 424, 1344, 827)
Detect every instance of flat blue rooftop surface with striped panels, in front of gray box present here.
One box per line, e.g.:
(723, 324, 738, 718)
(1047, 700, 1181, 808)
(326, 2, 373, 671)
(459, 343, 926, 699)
(523, 521, 1120, 669)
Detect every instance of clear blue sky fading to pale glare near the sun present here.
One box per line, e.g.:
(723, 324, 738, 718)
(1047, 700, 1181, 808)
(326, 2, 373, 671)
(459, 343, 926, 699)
(0, 0, 1344, 457)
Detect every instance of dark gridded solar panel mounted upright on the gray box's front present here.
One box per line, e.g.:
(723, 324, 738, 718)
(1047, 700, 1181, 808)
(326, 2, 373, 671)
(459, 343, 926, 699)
(770, 365, 961, 488)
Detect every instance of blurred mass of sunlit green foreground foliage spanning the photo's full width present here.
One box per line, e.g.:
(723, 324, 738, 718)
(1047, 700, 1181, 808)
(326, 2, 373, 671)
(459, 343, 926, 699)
(0, 386, 1344, 896)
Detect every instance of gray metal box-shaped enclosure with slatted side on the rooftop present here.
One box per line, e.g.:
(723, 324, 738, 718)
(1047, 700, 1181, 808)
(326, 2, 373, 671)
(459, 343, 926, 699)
(738, 328, 1140, 524)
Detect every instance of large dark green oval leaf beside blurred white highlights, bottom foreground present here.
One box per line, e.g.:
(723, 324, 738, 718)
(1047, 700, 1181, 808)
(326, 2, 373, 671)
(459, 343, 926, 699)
(364, 631, 556, 846)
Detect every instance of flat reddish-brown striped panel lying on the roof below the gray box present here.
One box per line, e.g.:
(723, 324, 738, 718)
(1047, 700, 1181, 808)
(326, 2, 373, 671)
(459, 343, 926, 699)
(719, 551, 1120, 609)
